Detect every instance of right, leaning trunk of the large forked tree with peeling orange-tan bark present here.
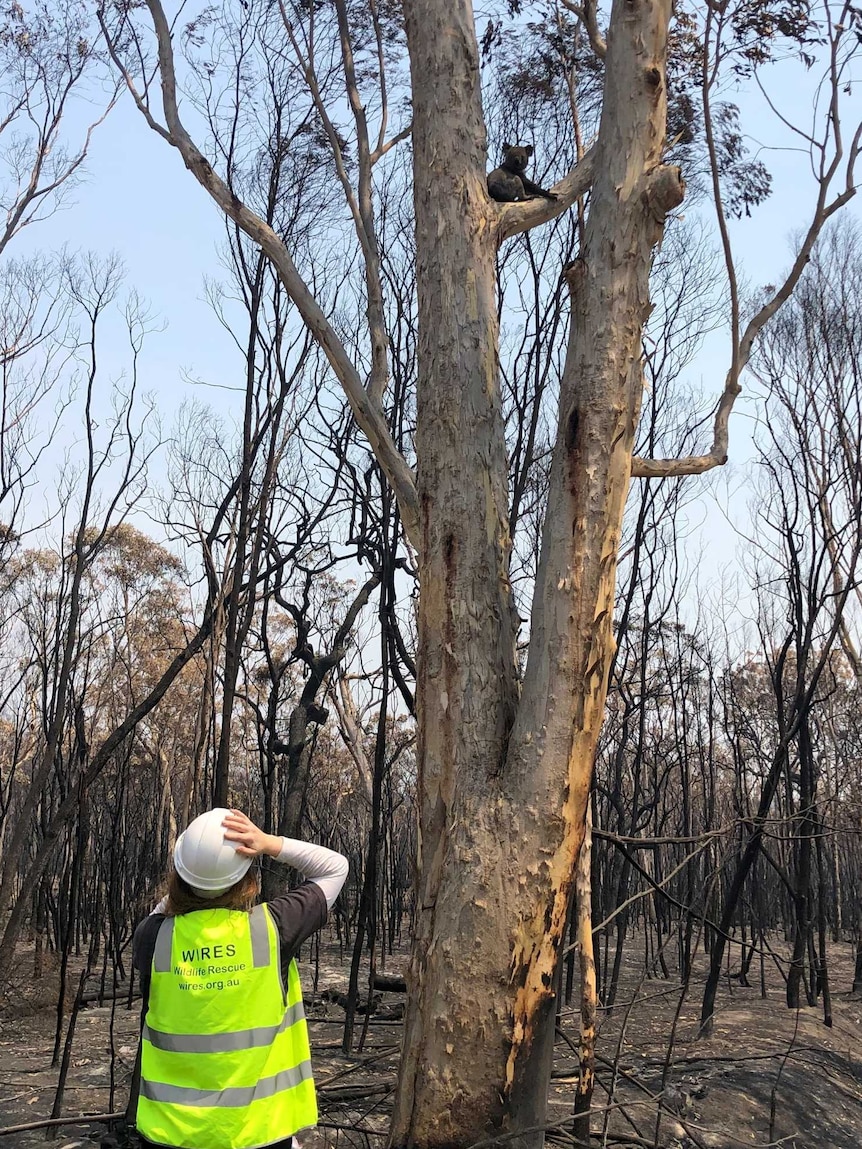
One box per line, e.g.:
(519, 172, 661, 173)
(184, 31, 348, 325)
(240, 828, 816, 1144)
(498, 0, 684, 1128)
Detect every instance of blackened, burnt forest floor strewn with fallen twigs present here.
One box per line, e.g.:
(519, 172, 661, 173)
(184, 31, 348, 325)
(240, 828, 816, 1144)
(0, 939, 862, 1149)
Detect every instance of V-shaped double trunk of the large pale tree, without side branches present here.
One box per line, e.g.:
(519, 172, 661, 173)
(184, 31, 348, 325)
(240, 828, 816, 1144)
(392, 0, 683, 1146)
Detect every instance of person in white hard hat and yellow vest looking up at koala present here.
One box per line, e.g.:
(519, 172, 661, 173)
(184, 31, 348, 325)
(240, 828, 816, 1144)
(132, 808, 347, 1149)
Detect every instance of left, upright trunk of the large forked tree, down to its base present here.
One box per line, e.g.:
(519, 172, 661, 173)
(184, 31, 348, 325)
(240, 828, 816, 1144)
(392, 0, 524, 1146)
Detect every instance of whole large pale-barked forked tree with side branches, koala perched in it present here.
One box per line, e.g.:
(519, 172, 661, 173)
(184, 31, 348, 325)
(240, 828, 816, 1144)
(102, 0, 860, 1147)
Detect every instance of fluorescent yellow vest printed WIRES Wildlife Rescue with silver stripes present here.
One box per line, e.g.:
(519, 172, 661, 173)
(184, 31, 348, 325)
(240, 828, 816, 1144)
(137, 905, 317, 1149)
